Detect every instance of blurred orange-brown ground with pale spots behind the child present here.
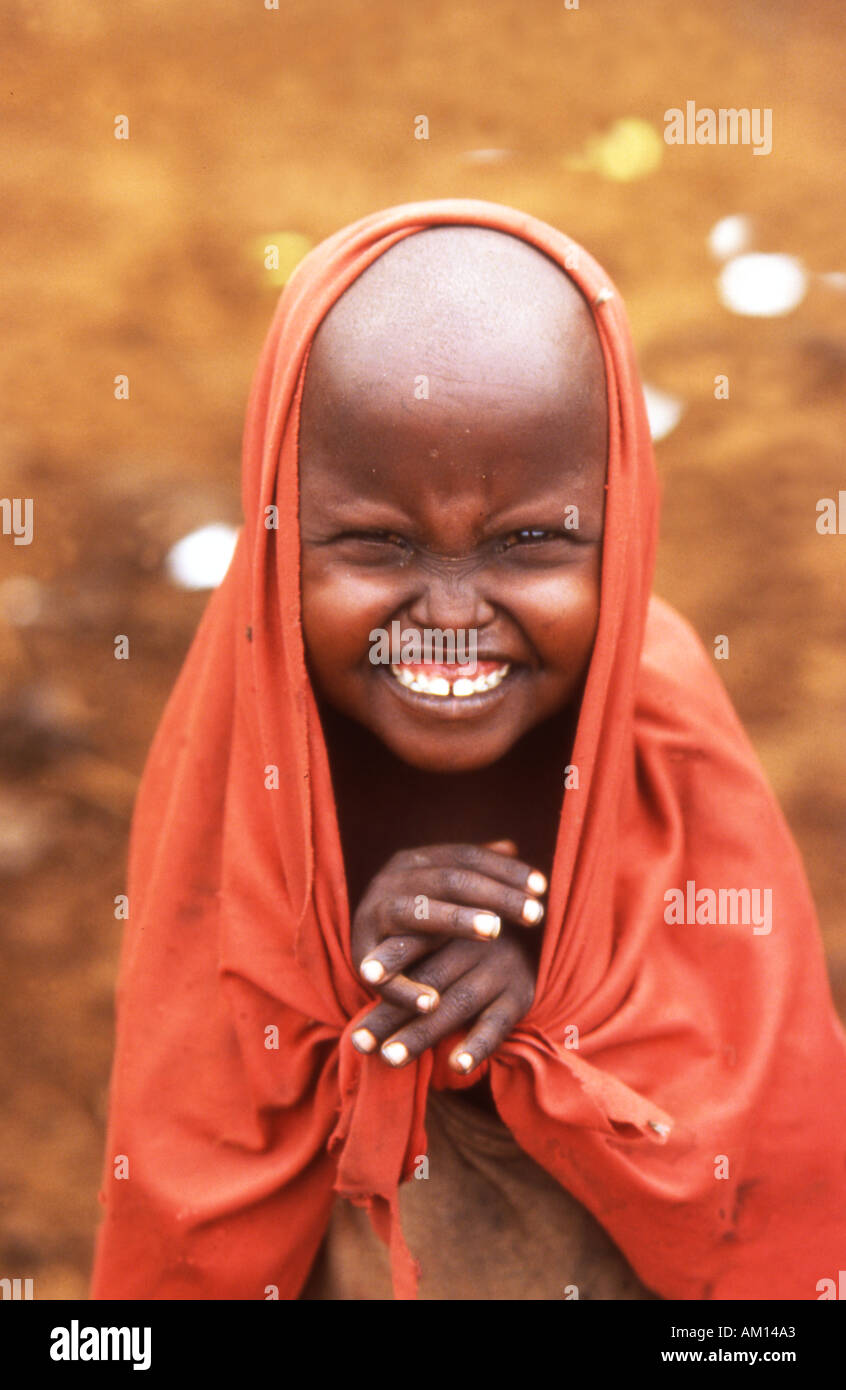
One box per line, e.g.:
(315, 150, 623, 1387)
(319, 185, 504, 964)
(0, 0, 846, 1298)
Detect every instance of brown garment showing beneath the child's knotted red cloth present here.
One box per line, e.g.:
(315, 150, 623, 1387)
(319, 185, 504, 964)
(300, 1091, 656, 1301)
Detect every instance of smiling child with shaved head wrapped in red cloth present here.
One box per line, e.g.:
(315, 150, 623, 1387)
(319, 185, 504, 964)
(93, 200, 846, 1300)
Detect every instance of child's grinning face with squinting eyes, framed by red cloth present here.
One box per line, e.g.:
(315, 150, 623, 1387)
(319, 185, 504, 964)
(300, 234, 607, 771)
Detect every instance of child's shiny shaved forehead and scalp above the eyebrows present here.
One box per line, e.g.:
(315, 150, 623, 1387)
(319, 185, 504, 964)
(300, 227, 607, 528)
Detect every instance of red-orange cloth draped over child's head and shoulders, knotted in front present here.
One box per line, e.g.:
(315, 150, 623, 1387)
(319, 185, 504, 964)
(93, 199, 846, 1300)
